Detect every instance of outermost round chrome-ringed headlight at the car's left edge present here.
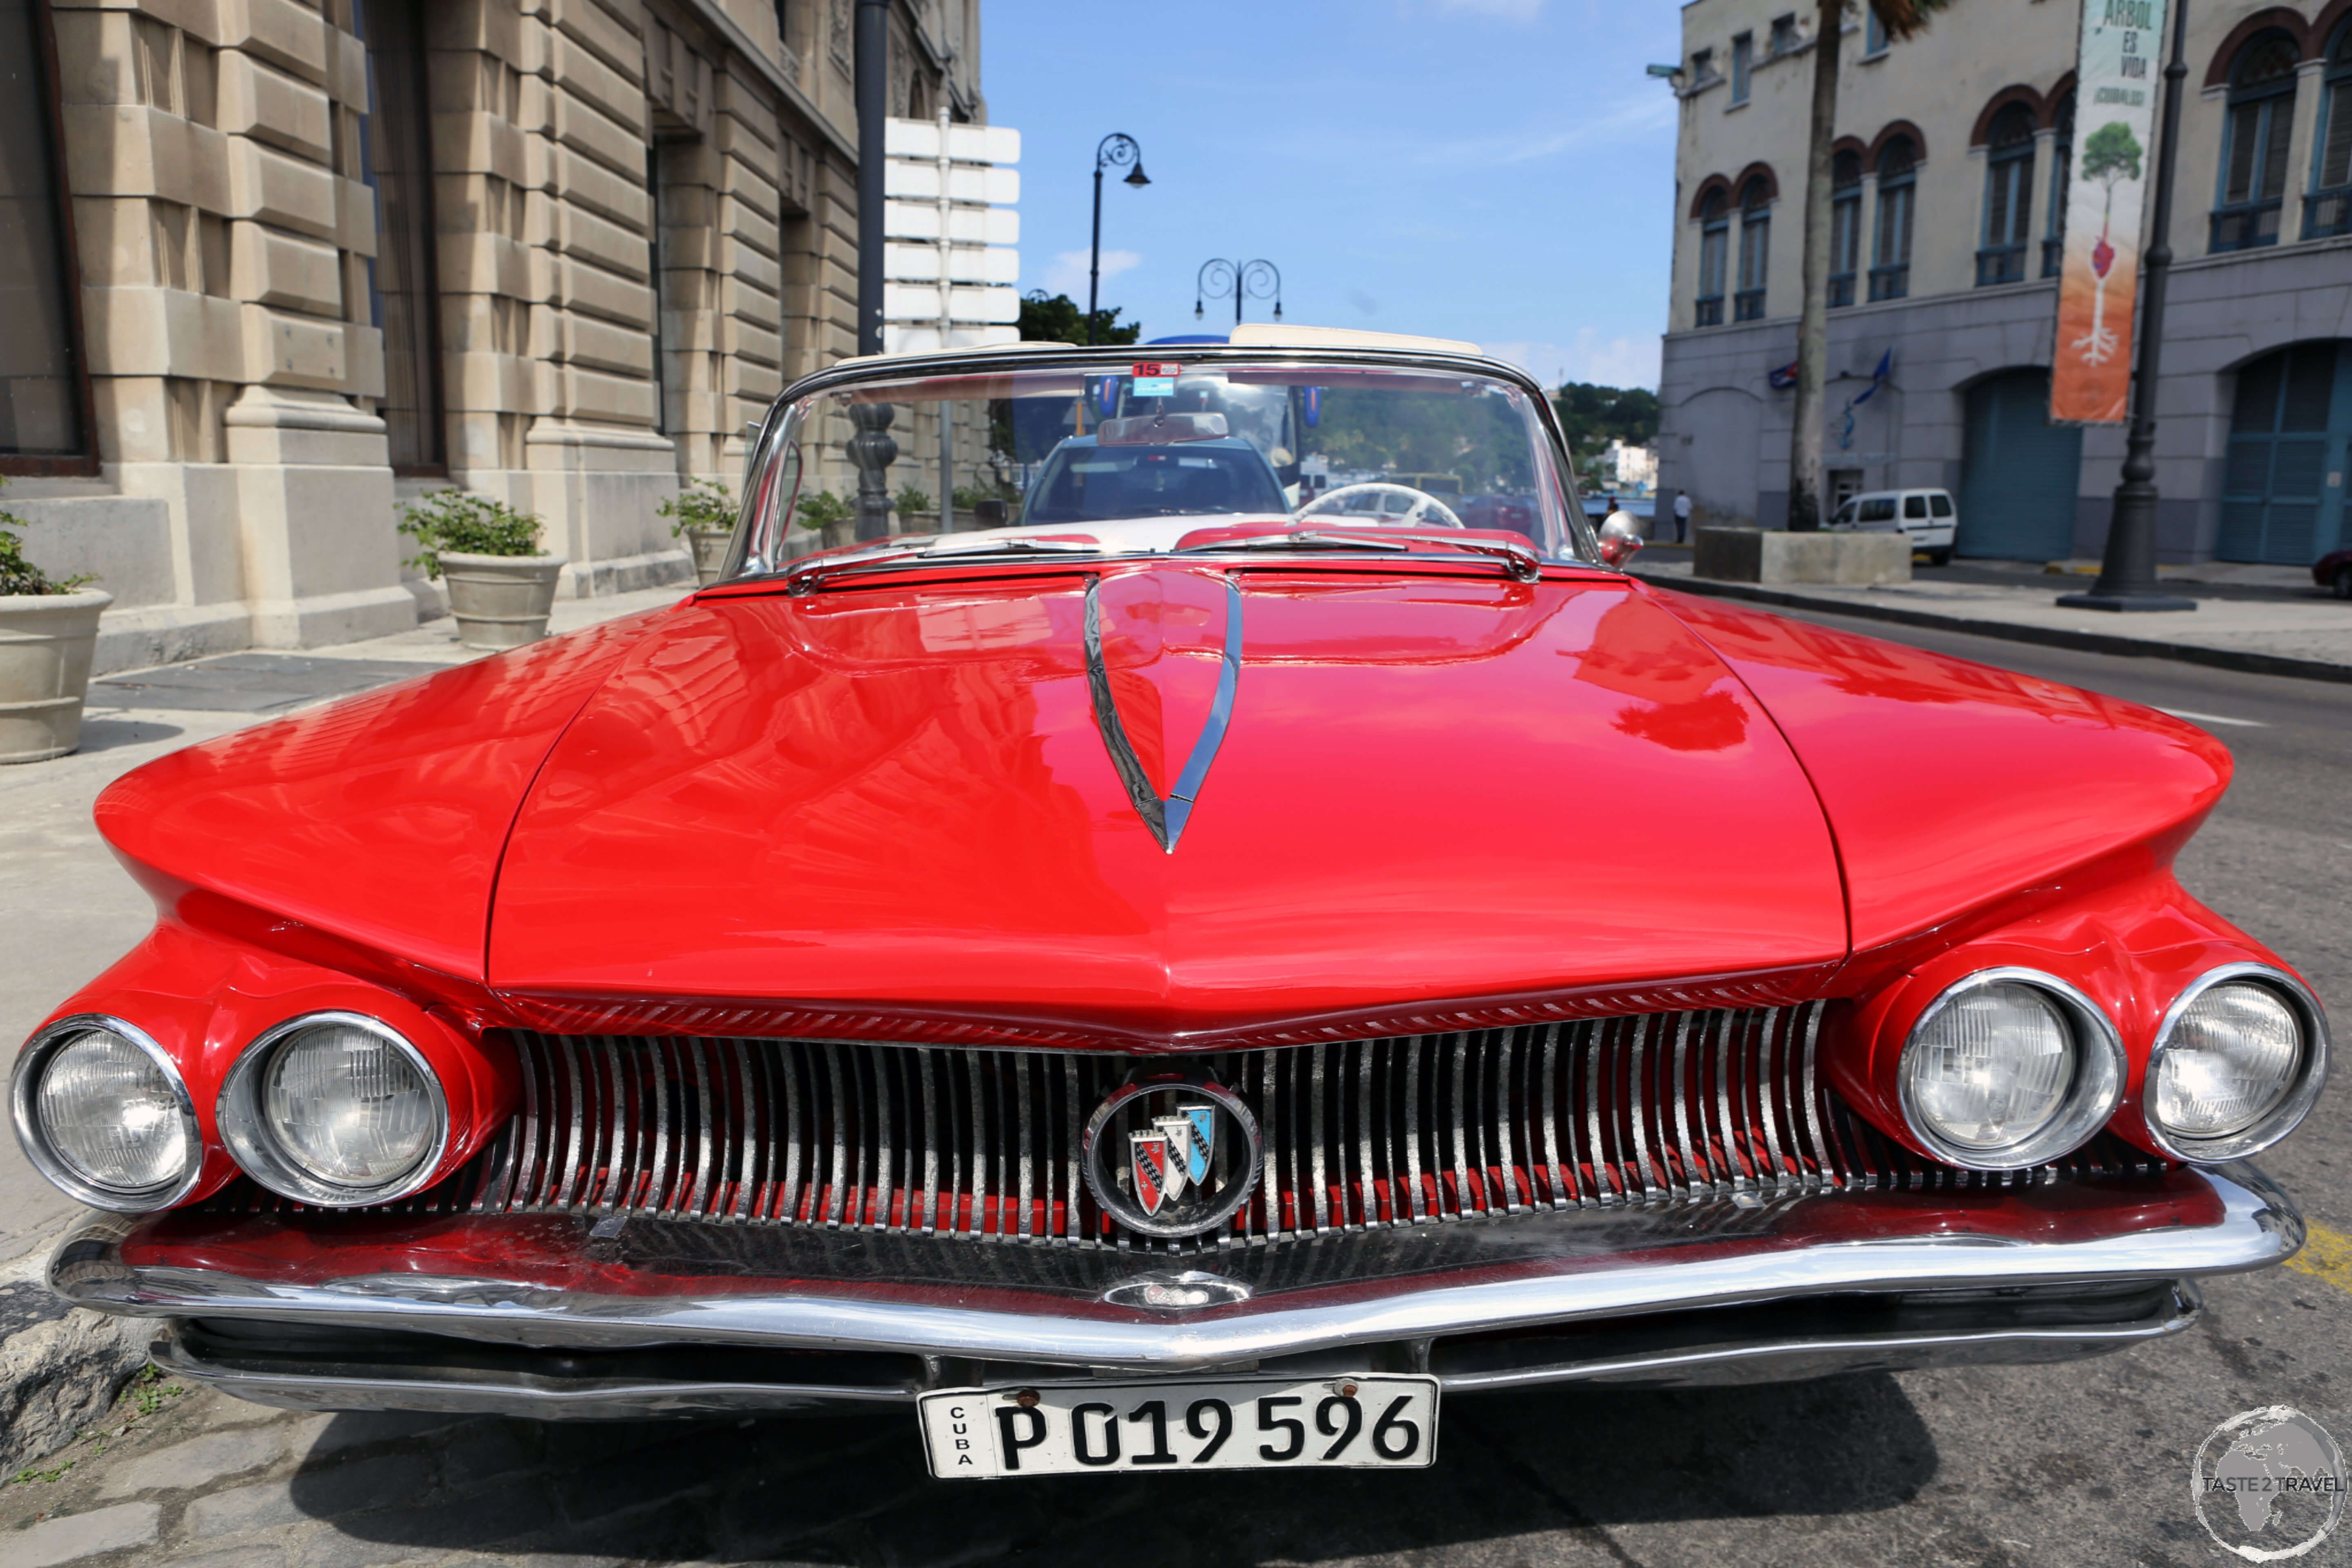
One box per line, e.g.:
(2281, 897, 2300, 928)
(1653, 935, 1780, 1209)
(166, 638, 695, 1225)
(9, 1016, 205, 1213)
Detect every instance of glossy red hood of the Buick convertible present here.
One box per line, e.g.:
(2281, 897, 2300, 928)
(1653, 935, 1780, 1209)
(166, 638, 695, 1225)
(489, 564, 1846, 1039)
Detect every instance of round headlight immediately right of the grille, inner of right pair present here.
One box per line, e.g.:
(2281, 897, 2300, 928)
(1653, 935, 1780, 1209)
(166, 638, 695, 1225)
(1898, 969, 2124, 1171)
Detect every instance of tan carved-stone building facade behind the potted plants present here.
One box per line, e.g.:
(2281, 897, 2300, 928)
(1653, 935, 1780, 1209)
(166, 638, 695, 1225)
(0, 0, 985, 668)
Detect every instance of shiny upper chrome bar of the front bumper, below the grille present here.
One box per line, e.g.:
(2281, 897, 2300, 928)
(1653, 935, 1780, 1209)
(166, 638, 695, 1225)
(49, 1164, 2303, 1370)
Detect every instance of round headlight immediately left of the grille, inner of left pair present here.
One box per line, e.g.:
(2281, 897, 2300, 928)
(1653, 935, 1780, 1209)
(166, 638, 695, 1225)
(219, 1013, 449, 1208)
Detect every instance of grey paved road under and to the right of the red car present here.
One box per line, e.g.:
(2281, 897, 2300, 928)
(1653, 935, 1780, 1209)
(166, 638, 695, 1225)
(0, 616, 2352, 1568)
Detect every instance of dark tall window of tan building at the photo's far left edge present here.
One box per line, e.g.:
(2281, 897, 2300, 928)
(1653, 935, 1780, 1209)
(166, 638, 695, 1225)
(0, 0, 89, 472)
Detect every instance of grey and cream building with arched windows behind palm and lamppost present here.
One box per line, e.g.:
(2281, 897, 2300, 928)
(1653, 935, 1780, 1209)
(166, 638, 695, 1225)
(1661, 0, 2352, 564)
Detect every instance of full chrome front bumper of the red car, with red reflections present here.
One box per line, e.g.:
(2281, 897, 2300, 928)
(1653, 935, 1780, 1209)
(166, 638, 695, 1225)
(49, 1164, 2303, 1415)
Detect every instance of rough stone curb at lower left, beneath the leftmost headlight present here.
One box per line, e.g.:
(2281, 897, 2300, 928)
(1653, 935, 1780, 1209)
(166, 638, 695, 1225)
(0, 1215, 155, 1483)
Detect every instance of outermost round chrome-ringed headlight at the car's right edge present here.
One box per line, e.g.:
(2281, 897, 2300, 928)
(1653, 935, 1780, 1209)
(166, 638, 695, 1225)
(2140, 964, 2328, 1164)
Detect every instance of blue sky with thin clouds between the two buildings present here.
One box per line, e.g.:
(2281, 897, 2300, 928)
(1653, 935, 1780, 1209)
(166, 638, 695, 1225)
(981, 0, 1679, 385)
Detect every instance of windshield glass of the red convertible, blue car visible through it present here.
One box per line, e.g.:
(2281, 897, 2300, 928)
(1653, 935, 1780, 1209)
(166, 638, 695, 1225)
(739, 348, 1590, 574)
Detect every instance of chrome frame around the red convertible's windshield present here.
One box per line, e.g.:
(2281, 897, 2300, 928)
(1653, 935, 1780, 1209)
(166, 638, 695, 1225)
(713, 343, 1616, 586)
